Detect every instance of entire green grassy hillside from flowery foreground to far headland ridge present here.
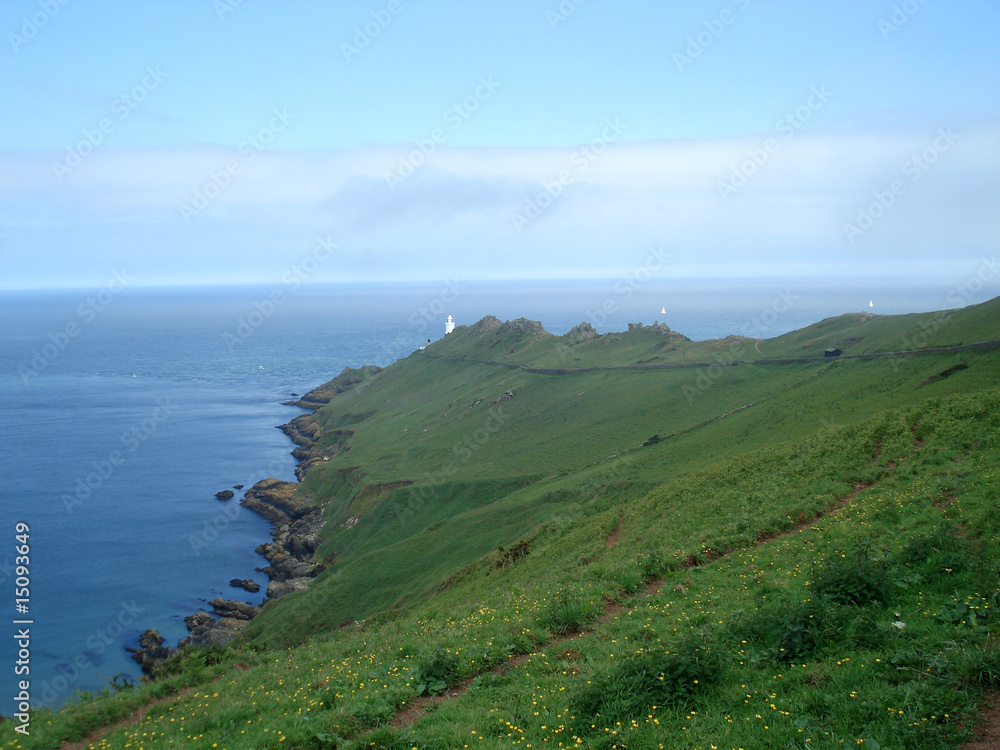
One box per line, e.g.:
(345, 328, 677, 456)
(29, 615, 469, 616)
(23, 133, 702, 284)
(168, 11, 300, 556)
(9, 300, 1000, 748)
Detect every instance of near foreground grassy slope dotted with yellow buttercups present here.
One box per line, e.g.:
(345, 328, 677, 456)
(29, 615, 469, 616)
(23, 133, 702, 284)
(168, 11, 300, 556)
(19, 387, 1000, 750)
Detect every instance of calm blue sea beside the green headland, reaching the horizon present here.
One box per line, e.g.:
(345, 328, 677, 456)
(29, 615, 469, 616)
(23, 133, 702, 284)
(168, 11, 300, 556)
(0, 269, 1000, 715)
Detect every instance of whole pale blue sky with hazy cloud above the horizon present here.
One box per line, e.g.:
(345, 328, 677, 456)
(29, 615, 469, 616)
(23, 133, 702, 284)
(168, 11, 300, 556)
(0, 0, 1000, 289)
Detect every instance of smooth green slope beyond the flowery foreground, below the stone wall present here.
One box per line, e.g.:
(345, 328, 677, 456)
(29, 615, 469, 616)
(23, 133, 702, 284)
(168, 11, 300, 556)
(242, 296, 1000, 645)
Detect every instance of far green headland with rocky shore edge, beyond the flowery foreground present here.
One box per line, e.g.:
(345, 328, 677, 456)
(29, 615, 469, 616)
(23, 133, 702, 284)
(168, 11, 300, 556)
(131, 302, 991, 672)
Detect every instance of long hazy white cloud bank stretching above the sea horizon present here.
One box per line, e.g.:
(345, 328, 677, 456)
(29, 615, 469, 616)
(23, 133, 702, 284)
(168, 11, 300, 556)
(0, 125, 1000, 284)
